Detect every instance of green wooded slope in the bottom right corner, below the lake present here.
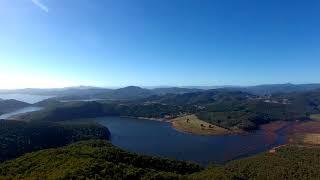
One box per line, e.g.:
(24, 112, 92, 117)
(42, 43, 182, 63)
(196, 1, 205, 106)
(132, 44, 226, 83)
(190, 146, 320, 180)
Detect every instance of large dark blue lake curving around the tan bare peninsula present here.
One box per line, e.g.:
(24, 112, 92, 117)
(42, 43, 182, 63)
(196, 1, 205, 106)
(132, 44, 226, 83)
(96, 117, 286, 165)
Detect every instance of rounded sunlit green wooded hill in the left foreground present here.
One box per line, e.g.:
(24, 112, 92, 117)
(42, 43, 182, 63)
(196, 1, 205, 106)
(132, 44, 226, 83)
(0, 140, 201, 179)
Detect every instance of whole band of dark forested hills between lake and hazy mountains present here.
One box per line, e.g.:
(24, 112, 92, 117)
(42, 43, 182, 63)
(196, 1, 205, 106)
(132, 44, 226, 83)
(20, 89, 320, 130)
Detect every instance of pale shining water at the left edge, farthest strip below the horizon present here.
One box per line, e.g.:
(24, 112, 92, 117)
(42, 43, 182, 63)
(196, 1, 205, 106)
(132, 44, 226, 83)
(0, 94, 53, 104)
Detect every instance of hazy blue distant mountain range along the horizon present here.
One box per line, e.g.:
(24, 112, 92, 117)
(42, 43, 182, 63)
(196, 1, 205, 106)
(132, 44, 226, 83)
(0, 84, 320, 100)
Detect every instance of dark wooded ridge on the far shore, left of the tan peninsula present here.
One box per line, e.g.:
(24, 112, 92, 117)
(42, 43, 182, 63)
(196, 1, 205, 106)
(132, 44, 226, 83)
(17, 102, 191, 121)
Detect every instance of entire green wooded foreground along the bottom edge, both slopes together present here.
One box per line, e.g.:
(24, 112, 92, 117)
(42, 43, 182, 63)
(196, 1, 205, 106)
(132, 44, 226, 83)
(0, 141, 320, 180)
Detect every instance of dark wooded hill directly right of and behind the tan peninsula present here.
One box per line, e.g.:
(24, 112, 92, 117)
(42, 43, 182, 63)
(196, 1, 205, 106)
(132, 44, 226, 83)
(197, 100, 310, 130)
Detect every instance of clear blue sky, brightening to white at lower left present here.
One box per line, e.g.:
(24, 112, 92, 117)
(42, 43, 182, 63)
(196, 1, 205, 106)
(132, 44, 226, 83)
(0, 0, 320, 88)
